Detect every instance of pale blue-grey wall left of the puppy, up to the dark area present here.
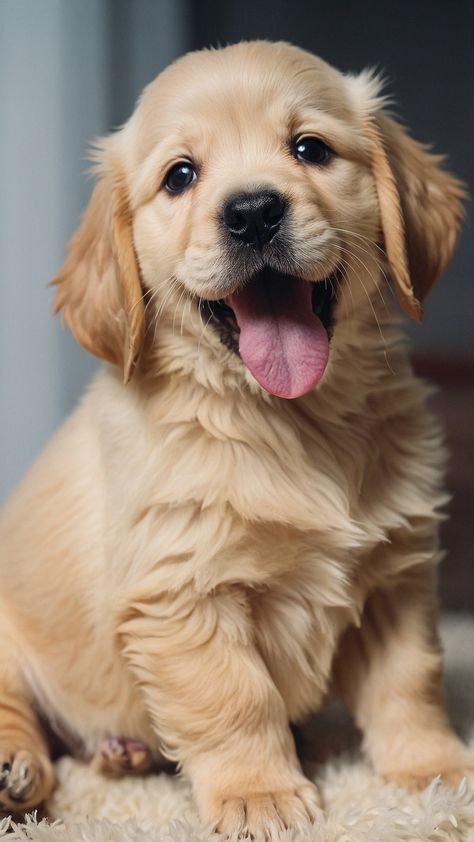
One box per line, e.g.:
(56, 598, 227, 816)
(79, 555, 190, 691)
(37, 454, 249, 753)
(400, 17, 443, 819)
(0, 0, 187, 501)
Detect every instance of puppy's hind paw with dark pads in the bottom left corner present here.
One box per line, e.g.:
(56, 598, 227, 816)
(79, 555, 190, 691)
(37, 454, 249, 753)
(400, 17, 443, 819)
(0, 746, 54, 813)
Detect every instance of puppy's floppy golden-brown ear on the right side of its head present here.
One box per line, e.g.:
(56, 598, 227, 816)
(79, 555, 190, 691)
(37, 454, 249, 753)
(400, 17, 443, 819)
(367, 112, 466, 321)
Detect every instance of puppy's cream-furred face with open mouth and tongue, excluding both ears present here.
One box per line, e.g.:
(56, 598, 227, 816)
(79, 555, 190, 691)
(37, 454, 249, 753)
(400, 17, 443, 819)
(129, 44, 379, 398)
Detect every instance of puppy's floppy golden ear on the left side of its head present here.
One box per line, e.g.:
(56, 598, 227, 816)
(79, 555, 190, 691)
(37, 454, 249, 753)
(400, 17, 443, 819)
(52, 175, 145, 383)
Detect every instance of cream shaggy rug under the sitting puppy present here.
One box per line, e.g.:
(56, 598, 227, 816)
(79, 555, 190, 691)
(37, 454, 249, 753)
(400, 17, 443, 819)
(0, 615, 474, 842)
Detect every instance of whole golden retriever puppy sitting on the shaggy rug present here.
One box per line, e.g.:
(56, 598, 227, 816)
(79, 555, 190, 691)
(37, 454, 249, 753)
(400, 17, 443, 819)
(0, 42, 474, 834)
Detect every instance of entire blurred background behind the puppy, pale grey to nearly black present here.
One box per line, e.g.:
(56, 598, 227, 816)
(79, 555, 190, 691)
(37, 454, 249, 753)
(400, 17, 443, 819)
(0, 0, 474, 604)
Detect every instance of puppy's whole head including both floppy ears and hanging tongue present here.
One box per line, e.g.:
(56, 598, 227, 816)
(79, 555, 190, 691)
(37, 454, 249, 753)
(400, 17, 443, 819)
(56, 42, 463, 398)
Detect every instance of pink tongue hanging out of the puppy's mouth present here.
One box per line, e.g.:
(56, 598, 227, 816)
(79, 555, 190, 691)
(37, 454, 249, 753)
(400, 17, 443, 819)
(227, 272, 329, 398)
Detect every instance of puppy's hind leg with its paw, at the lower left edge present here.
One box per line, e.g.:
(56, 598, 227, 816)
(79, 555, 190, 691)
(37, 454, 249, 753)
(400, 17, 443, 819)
(0, 641, 54, 813)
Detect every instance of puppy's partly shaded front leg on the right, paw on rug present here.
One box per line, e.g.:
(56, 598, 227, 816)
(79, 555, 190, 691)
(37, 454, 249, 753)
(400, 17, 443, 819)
(335, 564, 474, 788)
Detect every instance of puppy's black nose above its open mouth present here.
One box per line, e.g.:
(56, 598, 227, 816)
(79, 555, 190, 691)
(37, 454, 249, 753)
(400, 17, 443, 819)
(223, 190, 286, 248)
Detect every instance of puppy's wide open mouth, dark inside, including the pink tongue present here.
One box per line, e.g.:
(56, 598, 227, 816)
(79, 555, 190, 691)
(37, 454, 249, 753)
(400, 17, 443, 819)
(200, 267, 338, 398)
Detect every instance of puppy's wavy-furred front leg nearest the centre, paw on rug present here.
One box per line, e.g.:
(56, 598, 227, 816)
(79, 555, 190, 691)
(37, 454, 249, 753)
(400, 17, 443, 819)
(120, 587, 320, 833)
